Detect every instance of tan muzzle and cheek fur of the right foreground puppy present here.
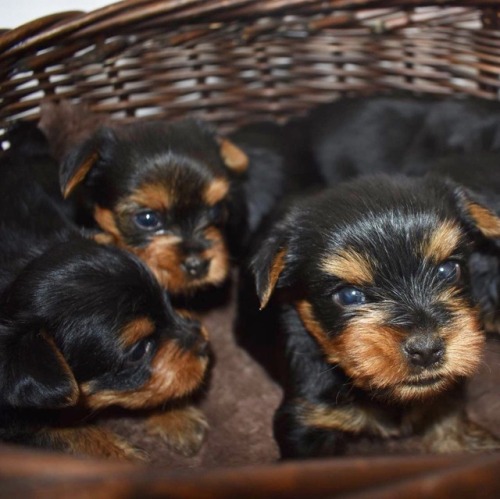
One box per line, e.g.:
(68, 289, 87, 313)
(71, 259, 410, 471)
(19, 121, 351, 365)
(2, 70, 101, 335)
(295, 295, 484, 400)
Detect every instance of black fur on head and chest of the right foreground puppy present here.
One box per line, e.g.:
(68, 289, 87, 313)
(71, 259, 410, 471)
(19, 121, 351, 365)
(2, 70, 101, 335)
(252, 175, 497, 457)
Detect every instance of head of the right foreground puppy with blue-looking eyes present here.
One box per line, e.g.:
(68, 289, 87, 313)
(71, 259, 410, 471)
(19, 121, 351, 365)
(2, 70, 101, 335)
(253, 177, 500, 400)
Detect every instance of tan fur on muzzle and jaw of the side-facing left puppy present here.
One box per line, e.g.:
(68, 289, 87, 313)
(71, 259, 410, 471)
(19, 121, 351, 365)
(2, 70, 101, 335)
(81, 341, 208, 409)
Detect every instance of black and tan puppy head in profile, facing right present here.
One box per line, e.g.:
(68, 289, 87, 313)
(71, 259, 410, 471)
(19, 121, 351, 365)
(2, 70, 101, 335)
(0, 241, 208, 408)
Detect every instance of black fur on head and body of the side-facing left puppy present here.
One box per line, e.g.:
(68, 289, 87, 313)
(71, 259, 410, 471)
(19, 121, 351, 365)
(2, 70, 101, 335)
(0, 124, 206, 458)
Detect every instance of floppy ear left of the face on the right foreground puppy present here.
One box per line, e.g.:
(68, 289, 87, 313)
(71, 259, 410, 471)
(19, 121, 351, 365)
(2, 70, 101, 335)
(251, 224, 289, 310)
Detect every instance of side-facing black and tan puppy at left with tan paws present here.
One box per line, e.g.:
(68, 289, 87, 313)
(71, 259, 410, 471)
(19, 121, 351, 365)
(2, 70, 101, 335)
(0, 125, 208, 459)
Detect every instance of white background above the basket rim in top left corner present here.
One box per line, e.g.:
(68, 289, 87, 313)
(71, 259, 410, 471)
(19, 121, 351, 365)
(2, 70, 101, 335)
(0, 0, 116, 28)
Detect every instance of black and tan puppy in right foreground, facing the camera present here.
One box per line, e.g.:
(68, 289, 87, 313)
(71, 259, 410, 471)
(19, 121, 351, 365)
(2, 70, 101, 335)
(252, 175, 500, 458)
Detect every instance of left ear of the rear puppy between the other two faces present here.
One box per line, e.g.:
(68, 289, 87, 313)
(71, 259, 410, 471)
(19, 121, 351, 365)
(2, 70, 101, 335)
(59, 127, 115, 199)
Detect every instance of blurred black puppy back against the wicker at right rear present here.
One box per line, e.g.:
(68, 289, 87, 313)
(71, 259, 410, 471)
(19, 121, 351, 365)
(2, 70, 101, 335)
(300, 94, 500, 185)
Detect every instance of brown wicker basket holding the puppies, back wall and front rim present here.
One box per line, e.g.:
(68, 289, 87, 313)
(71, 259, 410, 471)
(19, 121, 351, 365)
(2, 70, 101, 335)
(0, 0, 500, 498)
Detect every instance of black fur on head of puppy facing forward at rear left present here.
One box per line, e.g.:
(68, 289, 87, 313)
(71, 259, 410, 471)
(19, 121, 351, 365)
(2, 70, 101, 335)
(60, 120, 247, 295)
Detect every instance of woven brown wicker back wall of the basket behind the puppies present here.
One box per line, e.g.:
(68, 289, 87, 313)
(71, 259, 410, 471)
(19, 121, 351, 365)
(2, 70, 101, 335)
(0, 0, 500, 129)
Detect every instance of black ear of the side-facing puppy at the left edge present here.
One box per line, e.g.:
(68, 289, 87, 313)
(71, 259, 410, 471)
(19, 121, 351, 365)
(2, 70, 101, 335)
(0, 330, 79, 409)
